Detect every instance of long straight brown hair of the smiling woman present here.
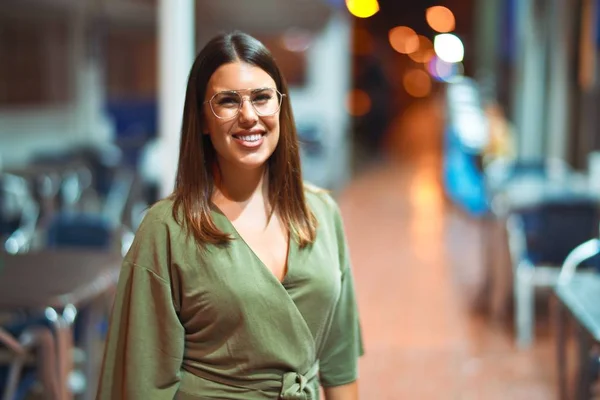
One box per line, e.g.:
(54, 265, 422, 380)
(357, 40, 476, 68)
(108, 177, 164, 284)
(171, 32, 317, 247)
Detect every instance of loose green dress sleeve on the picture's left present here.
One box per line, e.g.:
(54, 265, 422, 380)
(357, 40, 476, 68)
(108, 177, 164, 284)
(97, 219, 185, 400)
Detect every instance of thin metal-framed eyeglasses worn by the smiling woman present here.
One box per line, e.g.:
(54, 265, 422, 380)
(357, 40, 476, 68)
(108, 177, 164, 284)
(204, 88, 285, 119)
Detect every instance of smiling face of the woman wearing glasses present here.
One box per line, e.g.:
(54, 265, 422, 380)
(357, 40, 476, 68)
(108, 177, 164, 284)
(204, 62, 280, 169)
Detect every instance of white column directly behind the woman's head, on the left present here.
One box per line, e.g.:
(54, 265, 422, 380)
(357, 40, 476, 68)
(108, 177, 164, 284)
(158, 0, 195, 196)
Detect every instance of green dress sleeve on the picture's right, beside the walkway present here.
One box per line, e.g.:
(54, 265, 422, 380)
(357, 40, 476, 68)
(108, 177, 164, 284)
(319, 206, 364, 387)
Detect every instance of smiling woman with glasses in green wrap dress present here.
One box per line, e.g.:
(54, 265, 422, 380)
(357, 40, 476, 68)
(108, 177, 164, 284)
(98, 32, 362, 400)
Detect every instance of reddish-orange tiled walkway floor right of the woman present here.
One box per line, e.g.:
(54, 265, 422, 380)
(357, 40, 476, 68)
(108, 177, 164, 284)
(339, 97, 556, 400)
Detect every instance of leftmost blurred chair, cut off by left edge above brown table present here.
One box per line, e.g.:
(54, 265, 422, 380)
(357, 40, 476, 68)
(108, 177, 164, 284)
(0, 174, 39, 254)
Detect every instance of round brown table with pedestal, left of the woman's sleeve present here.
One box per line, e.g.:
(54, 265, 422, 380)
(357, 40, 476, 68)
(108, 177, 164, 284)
(0, 250, 122, 399)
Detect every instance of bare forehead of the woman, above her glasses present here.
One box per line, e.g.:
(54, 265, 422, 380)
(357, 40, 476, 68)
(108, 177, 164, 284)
(208, 62, 276, 93)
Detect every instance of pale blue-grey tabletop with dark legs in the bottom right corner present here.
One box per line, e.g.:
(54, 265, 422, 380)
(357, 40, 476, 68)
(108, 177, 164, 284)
(554, 275, 600, 399)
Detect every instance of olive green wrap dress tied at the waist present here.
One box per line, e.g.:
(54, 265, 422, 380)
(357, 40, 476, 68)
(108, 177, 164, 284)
(97, 189, 363, 400)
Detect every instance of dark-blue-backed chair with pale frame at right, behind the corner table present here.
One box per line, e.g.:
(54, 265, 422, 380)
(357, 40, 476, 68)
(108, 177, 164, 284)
(507, 196, 600, 347)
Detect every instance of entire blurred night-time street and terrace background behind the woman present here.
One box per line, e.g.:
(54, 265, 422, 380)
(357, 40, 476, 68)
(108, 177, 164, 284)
(0, 0, 600, 400)
